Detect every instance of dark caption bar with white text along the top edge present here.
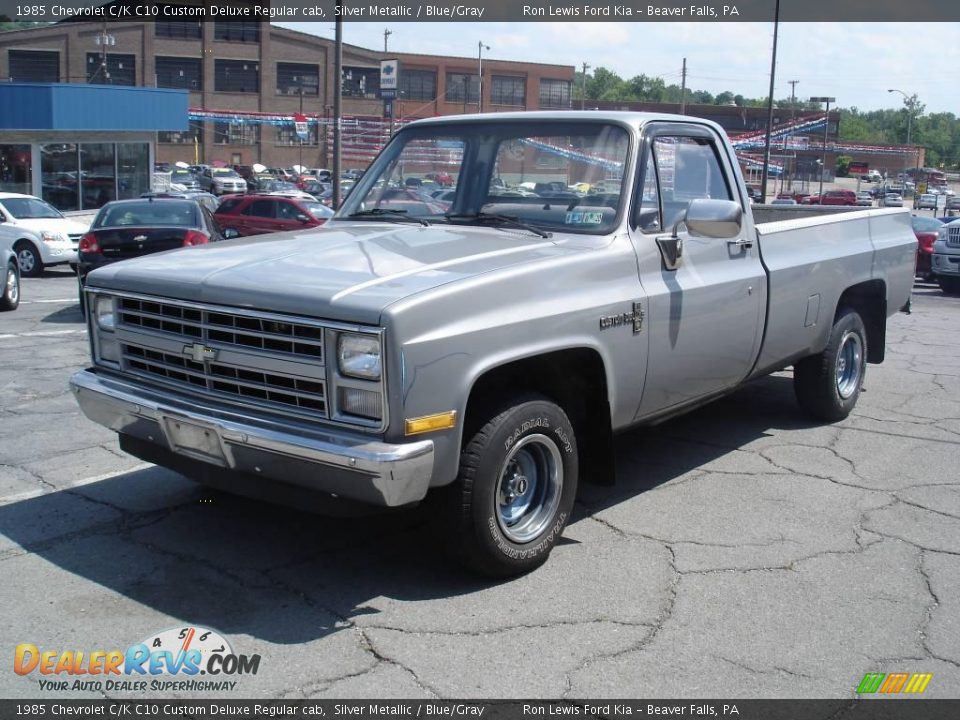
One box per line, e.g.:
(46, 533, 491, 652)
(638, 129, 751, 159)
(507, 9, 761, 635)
(0, 0, 960, 22)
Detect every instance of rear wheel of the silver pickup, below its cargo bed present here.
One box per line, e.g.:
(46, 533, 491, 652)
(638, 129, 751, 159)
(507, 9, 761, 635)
(793, 308, 867, 422)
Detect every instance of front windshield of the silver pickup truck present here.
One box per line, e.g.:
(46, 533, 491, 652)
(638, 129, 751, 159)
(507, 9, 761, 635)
(336, 120, 630, 233)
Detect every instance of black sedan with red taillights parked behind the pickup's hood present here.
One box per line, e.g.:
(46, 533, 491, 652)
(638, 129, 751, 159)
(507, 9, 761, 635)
(77, 196, 230, 308)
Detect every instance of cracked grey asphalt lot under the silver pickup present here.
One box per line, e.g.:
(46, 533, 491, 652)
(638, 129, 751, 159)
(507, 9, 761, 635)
(0, 269, 960, 699)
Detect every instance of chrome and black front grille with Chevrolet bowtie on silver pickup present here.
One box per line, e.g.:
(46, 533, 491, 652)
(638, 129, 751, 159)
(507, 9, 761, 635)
(117, 297, 330, 418)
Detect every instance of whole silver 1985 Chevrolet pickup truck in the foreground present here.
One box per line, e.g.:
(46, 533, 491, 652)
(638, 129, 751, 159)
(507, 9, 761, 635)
(71, 112, 916, 575)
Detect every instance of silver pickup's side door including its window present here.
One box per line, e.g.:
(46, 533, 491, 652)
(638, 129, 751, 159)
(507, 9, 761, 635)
(631, 123, 766, 417)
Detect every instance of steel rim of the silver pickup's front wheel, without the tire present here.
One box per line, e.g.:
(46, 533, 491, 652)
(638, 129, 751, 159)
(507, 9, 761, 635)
(494, 434, 563, 544)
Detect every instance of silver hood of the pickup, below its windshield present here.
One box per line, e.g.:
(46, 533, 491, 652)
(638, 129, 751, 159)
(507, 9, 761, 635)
(87, 221, 574, 325)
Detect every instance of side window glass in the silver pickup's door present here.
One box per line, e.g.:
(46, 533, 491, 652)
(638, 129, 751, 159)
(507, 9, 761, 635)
(653, 135, 733, 228)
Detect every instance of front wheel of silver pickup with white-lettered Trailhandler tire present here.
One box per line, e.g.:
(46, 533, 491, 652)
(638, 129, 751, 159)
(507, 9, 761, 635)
(445, 397, 578, 577)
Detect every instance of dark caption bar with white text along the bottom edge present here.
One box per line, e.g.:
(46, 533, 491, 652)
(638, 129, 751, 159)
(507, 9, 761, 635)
(0, 697, 960, 720)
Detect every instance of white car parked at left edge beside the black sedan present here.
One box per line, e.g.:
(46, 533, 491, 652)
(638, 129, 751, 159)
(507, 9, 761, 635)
(0, 193, 89, 277)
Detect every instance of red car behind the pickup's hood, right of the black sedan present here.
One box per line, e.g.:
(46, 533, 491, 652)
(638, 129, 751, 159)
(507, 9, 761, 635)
(214, 195, 333, 236)
